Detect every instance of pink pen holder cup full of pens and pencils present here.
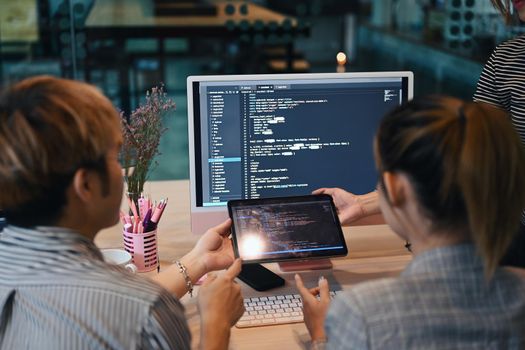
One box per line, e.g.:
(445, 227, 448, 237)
(122, 230, 159, 272)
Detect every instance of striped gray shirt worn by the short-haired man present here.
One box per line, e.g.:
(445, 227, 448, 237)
(0, 226, 191, 350)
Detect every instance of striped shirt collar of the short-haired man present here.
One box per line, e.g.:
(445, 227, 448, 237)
(0, 225, 103, 260)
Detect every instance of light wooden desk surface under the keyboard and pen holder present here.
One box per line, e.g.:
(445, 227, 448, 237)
(95, 180, 411, 349)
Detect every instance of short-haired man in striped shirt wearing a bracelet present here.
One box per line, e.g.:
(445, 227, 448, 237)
(0, 76, 244, 350)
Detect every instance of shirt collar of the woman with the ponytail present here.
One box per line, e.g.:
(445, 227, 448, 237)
(401, 243, 483, 276)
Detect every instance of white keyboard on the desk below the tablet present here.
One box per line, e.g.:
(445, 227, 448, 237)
(235, 291, 338, 328)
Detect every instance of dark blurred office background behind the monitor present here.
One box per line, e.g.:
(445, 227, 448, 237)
(0, 0, 523, 179)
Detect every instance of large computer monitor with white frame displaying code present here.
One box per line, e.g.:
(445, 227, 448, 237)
(187, 72, 413, 233)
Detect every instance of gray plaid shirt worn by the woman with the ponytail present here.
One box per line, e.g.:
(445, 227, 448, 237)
(319, 244, 525, 350)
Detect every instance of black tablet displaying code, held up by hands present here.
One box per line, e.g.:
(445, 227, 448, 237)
(228, 195, 348, 263)
